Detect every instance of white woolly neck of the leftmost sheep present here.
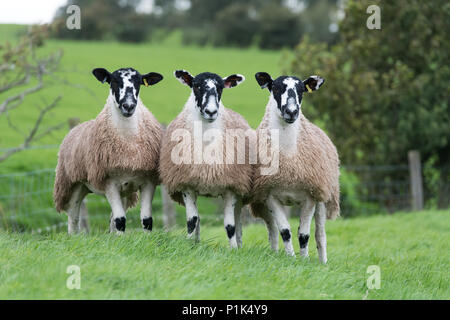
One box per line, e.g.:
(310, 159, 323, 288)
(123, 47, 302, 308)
(107, 93, 142, 138)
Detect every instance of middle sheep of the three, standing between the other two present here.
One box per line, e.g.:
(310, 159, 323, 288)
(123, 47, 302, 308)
(160, 70, 256, 248)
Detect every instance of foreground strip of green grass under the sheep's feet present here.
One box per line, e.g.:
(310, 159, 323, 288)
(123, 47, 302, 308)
(0, 211, 450, 299)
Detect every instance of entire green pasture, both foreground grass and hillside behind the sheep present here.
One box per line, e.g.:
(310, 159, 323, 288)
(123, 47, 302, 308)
(0, 25, 450, 299)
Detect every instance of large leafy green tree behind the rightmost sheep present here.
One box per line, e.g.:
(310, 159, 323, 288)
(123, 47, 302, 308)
(286, 0, 450, 165)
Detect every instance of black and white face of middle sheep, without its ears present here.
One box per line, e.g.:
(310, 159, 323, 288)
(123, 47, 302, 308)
(192, 72, 225, 122)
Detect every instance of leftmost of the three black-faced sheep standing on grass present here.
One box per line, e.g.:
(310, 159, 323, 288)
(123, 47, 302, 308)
(53, 68, 163, 234)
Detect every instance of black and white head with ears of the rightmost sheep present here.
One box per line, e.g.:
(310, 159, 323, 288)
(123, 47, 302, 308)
(255, 72, 325, 123)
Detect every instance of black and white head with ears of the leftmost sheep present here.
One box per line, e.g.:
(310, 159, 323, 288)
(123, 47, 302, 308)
(92, 68, 163, 118)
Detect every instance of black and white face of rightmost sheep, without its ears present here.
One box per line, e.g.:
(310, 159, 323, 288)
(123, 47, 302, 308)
(272, 76, 305, 123)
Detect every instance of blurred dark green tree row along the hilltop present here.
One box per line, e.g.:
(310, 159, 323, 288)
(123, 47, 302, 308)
(53, 0, 338, 49)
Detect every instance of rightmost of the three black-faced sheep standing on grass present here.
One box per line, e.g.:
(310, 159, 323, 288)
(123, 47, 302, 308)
(250, 72, 340, 263)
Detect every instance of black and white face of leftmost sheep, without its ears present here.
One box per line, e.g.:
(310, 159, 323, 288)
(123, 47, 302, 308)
(111, 68, 142, 118)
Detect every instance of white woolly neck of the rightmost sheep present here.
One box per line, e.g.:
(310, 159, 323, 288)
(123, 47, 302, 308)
(266, 94, 301, 157)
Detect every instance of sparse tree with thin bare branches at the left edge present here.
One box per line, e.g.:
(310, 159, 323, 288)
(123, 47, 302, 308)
(0, 26, 66, 162)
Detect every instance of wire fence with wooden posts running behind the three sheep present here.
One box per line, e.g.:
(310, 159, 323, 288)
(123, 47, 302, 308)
(0, 165, 450, 233)
